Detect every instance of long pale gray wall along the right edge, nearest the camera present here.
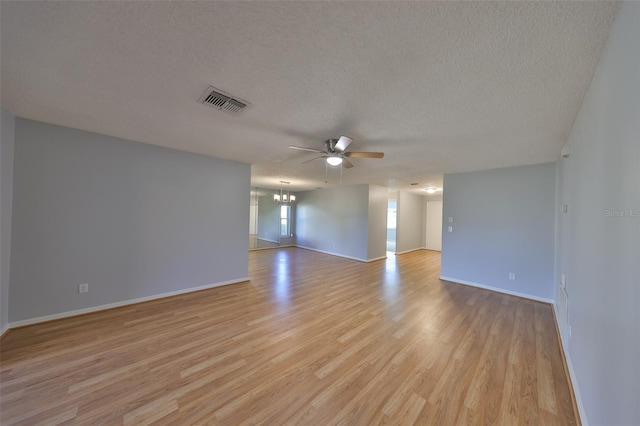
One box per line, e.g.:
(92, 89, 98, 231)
(555, 2, 640, 425)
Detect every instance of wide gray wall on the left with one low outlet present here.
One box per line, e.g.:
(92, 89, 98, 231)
(9, 118, 250, 321)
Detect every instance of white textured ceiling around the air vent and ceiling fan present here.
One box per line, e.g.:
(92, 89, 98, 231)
(0, 1, 618, 193)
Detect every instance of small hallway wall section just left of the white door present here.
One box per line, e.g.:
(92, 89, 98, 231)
(396, 191, 424, 253)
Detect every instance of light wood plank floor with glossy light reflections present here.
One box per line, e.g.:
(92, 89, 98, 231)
(0, 248, 576, 425)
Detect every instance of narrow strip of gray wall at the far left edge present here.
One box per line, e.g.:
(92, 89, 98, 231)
(0, 109, 15, 334)
